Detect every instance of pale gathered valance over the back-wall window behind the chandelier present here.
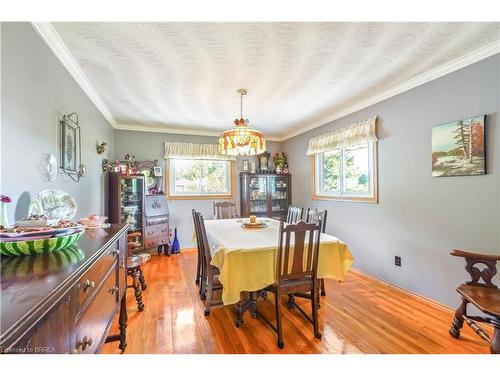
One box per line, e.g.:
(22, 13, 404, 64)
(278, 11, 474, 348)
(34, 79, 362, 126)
(165, 142, 236, 160)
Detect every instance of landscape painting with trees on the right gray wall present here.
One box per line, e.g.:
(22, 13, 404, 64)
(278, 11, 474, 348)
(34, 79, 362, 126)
(432, 115, 486, 177)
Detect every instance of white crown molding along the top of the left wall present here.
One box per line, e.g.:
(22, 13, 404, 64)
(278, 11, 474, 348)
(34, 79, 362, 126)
(31, 22, 116, 128)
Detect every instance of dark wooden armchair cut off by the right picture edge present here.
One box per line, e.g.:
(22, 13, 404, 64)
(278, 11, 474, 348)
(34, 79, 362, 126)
(449, 250, 500, 354)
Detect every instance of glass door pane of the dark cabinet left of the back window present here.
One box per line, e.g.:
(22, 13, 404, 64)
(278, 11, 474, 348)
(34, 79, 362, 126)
(120, 178, 144, 247)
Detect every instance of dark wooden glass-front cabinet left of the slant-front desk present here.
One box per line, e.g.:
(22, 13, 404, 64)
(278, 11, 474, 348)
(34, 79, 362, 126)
(109, 172, 146, 251)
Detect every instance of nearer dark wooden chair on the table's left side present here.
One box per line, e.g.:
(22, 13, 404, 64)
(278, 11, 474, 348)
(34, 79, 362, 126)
(196, 212, 222, 316)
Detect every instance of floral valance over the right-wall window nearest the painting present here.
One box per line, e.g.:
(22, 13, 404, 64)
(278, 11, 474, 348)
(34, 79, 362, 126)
(307, 116, 377, 155)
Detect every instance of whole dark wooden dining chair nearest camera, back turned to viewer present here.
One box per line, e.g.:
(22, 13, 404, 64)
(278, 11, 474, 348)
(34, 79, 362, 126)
(255, 220, 322, 348)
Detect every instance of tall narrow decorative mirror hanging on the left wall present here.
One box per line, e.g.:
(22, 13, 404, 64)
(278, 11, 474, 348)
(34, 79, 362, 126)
(60, 112, 85, 182)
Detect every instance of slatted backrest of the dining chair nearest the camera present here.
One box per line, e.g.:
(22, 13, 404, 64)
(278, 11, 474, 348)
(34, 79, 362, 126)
(276, 220, 320, 281)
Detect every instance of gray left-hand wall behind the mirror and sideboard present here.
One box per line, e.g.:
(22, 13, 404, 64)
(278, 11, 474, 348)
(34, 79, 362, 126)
(0, 22, 114, 223)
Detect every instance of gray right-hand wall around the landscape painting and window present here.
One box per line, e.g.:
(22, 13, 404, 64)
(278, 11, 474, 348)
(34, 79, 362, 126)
(283, 55, 500, 306)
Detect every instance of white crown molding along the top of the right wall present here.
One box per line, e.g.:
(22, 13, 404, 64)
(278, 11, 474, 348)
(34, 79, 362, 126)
(281, 40, 500, 142)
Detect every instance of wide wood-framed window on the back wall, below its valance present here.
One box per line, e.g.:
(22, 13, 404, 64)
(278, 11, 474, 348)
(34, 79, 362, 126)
(168, 159, 233, 199)
